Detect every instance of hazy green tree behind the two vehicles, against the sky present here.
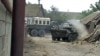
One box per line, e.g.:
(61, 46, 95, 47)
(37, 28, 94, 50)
(45, 6, 67, 23)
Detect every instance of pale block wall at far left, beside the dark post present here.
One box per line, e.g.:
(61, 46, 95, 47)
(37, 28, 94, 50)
(0, 1, 12, 56)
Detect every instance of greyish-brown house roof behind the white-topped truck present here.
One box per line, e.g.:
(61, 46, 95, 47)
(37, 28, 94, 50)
(25, 4, 44, 17)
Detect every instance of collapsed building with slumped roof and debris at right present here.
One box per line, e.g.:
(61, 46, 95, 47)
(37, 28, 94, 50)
(81, 11, 100, 42)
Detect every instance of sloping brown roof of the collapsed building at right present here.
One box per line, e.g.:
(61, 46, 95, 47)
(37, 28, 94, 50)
(81, 11, 100, 24)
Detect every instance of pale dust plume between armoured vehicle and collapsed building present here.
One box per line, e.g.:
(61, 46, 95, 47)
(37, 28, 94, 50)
(68, 19, 88, 40)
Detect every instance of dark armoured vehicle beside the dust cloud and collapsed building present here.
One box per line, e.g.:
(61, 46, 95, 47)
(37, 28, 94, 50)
(50, 22, 78, 42)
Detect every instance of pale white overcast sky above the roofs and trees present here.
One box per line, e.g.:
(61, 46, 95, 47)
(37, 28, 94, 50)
(26, 0, 98, 12)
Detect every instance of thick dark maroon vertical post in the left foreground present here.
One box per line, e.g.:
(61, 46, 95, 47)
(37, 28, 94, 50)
(11, 0, 25, 56)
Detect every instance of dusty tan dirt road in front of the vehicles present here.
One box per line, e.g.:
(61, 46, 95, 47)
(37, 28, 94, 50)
(24, 36, 100, 56)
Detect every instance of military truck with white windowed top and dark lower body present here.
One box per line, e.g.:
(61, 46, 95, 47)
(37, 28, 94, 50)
(26, 17, 50, 37)
